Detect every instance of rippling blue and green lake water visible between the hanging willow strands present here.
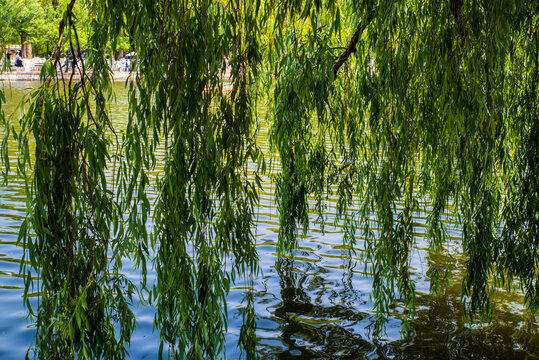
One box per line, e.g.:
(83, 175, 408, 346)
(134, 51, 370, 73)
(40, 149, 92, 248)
(0, 82, 539, 360)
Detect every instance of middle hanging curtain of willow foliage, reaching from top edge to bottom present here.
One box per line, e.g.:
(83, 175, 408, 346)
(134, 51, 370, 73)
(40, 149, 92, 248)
(90, 1, 260, 359)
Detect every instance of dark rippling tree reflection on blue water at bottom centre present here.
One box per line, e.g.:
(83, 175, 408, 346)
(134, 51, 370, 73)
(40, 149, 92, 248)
(275, 258, 373, 359)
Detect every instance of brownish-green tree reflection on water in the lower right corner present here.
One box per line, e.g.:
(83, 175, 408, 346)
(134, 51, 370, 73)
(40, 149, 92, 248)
(391, 291, 539, 359)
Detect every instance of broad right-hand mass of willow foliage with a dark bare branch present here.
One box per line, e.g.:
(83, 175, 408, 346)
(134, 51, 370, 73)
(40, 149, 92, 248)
(270, 0, 538, 330)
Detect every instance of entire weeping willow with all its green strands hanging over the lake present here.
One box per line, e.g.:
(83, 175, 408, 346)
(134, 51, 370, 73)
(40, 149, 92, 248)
(3, 0, 539, 359)
